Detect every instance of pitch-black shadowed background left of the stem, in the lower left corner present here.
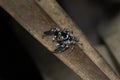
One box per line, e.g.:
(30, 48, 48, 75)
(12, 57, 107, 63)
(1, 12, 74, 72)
(0, 8, 42, 80)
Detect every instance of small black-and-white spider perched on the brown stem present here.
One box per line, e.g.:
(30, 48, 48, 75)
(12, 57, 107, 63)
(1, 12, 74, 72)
(44, 28, 79, 53)
